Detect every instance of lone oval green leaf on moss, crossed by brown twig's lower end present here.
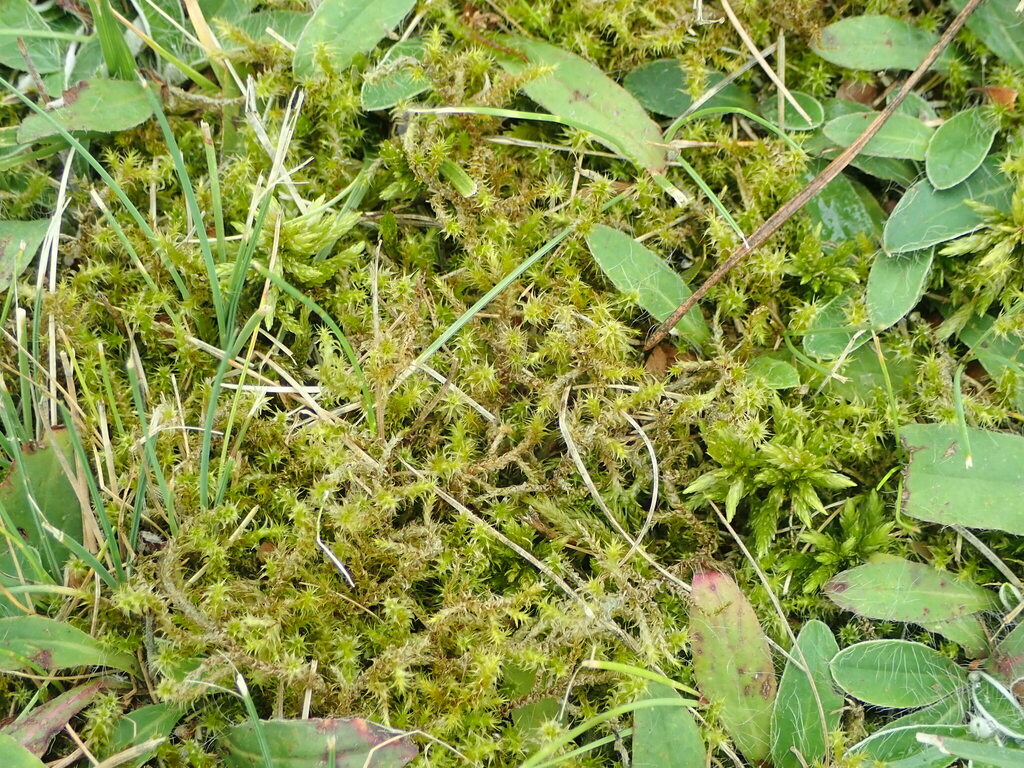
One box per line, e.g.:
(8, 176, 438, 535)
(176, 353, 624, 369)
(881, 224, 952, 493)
(587, 224, 711, 346)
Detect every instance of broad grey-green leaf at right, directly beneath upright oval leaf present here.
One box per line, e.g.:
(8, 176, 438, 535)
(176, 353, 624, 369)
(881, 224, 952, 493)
(884, 157, 1014, 253)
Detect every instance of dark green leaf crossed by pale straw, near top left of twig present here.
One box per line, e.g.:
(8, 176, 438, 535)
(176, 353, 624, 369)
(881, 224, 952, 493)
(623, 58, 758, 118)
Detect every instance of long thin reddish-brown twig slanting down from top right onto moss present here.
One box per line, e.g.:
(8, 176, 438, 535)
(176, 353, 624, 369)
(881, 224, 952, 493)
(644, 0, 982, 350)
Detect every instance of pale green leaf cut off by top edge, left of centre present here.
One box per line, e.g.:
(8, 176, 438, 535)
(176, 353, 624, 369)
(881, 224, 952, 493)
(292, 0, 416, 78)
